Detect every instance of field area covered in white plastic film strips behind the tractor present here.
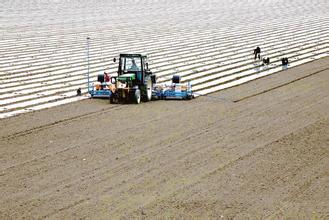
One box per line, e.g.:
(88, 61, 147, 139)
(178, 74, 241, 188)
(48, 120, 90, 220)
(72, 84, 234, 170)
(0, 0, 329, 118)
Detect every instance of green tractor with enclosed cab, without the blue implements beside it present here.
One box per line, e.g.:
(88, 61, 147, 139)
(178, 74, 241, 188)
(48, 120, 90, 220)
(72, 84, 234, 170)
(110, 54, 156, 104)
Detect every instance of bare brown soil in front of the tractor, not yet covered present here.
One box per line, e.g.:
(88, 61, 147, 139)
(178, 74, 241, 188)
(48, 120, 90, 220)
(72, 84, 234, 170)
(0, 58, 329, 219)
